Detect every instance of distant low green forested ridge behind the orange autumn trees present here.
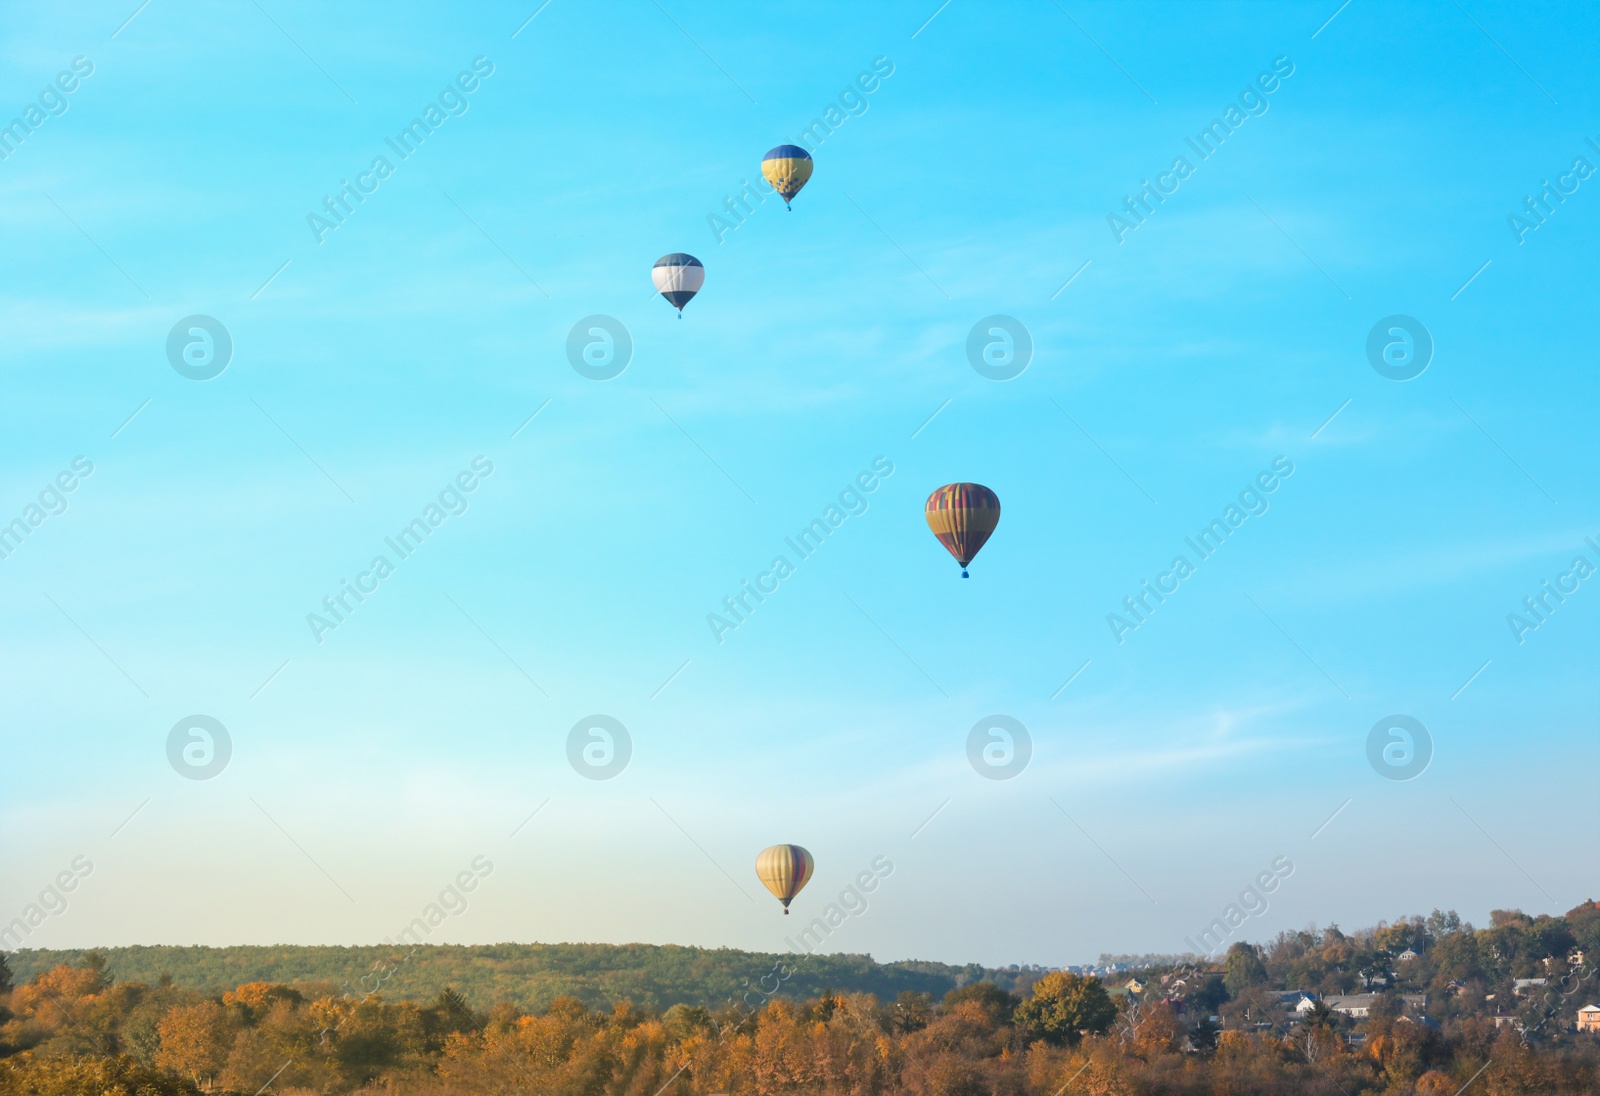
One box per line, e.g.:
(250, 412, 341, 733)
(8, 944, 1042, 1010)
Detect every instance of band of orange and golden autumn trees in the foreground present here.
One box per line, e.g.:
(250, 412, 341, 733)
(0, 962, 1600, 1096)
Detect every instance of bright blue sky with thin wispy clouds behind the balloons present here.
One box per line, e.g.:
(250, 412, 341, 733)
(0, 0, 1600, 963)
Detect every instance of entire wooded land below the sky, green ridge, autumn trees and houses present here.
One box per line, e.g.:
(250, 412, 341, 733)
(0, 901, 1600, 1096)
